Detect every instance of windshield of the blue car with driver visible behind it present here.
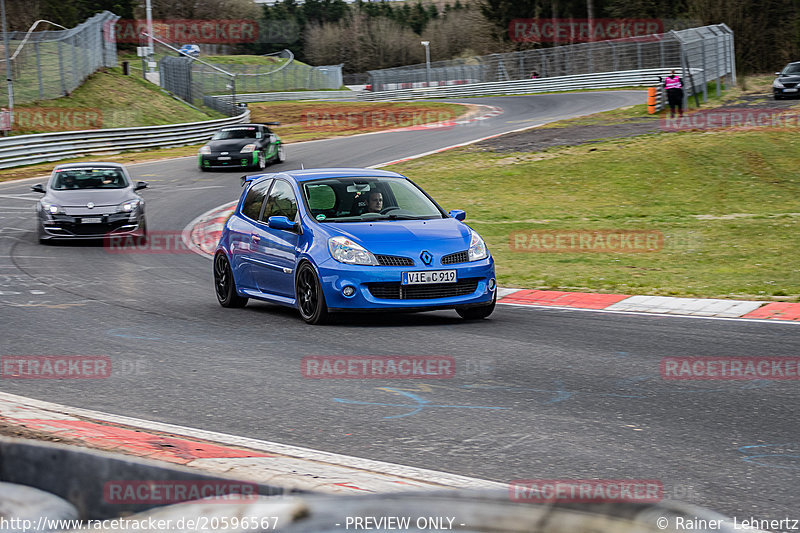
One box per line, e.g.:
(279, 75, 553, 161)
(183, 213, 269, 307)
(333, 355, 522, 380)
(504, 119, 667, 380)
(302, 177, 446, 222)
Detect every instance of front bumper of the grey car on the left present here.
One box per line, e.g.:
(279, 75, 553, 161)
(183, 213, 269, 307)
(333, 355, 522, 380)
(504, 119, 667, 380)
(38, 213, 145, 240)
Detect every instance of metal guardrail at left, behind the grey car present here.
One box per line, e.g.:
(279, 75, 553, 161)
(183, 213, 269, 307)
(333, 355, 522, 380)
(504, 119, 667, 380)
(0, 110, 250, 169)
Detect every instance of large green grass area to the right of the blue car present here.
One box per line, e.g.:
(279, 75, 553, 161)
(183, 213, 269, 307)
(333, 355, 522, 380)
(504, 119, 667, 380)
(391, 130, 800, 301)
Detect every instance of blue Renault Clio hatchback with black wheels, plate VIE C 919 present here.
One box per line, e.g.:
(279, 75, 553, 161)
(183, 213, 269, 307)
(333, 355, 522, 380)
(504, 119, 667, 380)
(213, 168, 497, 324)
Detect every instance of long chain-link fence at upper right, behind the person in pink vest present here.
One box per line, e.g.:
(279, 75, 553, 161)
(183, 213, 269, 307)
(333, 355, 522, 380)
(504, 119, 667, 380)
(369, 24, 735, 101)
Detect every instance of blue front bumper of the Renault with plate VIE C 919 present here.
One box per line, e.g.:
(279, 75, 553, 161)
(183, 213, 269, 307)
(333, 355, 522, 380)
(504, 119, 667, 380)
(317, 258, 497, 311)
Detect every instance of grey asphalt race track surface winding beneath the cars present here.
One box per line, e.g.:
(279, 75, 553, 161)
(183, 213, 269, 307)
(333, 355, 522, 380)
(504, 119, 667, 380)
(0, 92, 800, 519)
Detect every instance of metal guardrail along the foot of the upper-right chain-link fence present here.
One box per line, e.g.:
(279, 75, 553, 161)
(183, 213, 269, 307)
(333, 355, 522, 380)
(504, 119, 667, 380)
(358, 67, 701, 101)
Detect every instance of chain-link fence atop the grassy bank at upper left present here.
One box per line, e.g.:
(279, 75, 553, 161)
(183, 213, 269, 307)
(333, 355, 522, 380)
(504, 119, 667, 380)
(0, 11, 119, 107)
